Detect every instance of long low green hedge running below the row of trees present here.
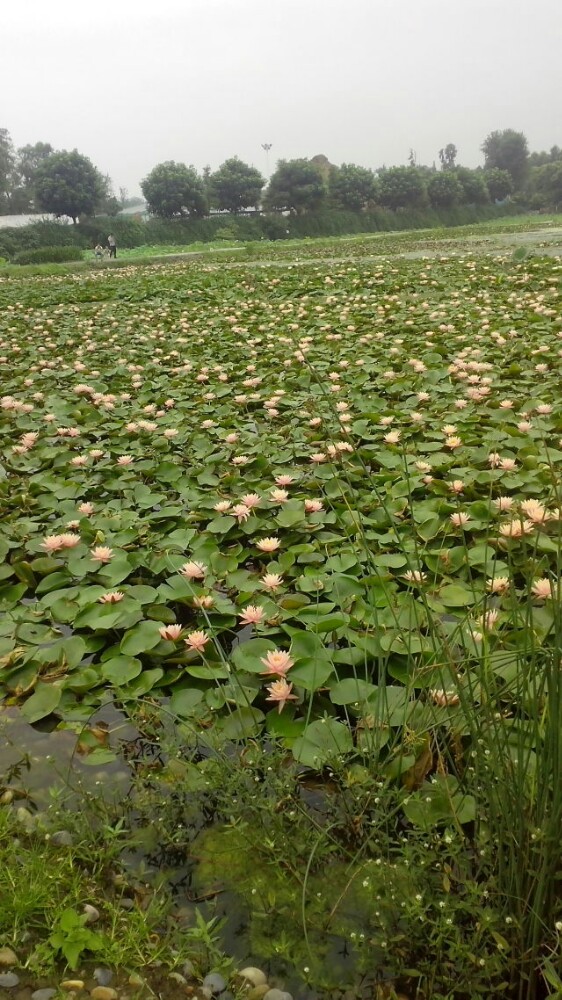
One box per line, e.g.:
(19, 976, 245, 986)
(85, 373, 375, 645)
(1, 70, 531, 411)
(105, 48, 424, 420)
(0, 205, 521, 259)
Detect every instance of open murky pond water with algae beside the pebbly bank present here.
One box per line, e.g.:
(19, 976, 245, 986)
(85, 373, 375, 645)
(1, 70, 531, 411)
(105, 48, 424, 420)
(0, 702, 394, 1000)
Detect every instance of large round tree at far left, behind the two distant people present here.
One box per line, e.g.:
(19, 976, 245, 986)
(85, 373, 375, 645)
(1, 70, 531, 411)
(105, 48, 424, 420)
(34, 149, 105, 223)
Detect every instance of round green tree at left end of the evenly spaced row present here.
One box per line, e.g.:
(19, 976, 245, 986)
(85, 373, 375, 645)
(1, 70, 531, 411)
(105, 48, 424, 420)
(141, 160, 208, 219)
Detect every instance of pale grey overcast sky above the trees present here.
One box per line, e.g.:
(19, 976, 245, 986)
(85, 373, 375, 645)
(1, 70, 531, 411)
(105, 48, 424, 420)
(0, 0, 562, 194)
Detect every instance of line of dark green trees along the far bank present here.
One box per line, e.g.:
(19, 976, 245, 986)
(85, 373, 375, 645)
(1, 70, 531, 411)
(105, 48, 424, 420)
(0, 129, 562, 222)
